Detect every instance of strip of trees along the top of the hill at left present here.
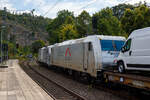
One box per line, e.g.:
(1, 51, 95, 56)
(0, 8, 51, 32)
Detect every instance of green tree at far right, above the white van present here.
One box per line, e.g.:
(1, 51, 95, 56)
(121, 4, 150, 35)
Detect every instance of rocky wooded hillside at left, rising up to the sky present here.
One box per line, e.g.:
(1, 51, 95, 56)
(0, 10, 50, 46)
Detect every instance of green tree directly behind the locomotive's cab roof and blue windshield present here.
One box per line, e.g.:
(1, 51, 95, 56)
(93, 8, 124, 35)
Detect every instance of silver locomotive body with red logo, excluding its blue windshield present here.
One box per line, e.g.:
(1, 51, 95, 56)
(39, 35, 125, 77)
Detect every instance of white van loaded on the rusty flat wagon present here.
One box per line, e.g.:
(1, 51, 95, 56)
(117, 27, 150, 73)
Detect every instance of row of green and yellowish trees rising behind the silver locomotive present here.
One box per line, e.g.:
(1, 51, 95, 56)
(47, 2, 150, 44)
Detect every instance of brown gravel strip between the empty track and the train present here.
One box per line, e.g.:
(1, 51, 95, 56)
(27, 62, 125, 100)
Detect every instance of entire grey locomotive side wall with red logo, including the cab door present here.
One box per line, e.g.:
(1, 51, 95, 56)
(51, 42, 97, 77)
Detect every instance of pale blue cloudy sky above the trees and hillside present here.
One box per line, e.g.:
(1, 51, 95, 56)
(0, 0, 150, 18)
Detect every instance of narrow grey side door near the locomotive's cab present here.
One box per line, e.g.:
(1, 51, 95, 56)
(83, 43, 89, 71)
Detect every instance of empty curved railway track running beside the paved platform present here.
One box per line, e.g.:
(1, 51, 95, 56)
(22, 62, 86, 100)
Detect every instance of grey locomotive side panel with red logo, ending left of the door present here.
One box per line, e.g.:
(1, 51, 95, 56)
(51, 43, 83, 71)
